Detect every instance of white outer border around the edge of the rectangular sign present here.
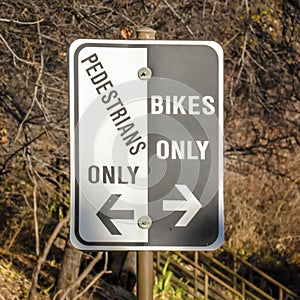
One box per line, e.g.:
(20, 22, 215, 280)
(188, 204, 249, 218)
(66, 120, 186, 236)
(68, 39, 224, 251)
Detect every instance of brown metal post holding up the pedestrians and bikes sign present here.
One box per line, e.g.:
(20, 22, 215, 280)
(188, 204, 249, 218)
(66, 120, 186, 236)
(136, 27, 156, 300)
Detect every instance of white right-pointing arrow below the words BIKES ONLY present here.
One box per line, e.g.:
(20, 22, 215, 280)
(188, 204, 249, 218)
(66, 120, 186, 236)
(163, 184, 202, 227)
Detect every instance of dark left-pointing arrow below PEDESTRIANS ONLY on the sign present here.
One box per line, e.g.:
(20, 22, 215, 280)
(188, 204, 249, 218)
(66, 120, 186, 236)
(97, 194, 134, 235)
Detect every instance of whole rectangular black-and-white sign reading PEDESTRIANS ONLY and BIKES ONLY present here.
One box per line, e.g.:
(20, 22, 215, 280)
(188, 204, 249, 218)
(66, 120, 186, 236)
(69, 40, 224, 250)
